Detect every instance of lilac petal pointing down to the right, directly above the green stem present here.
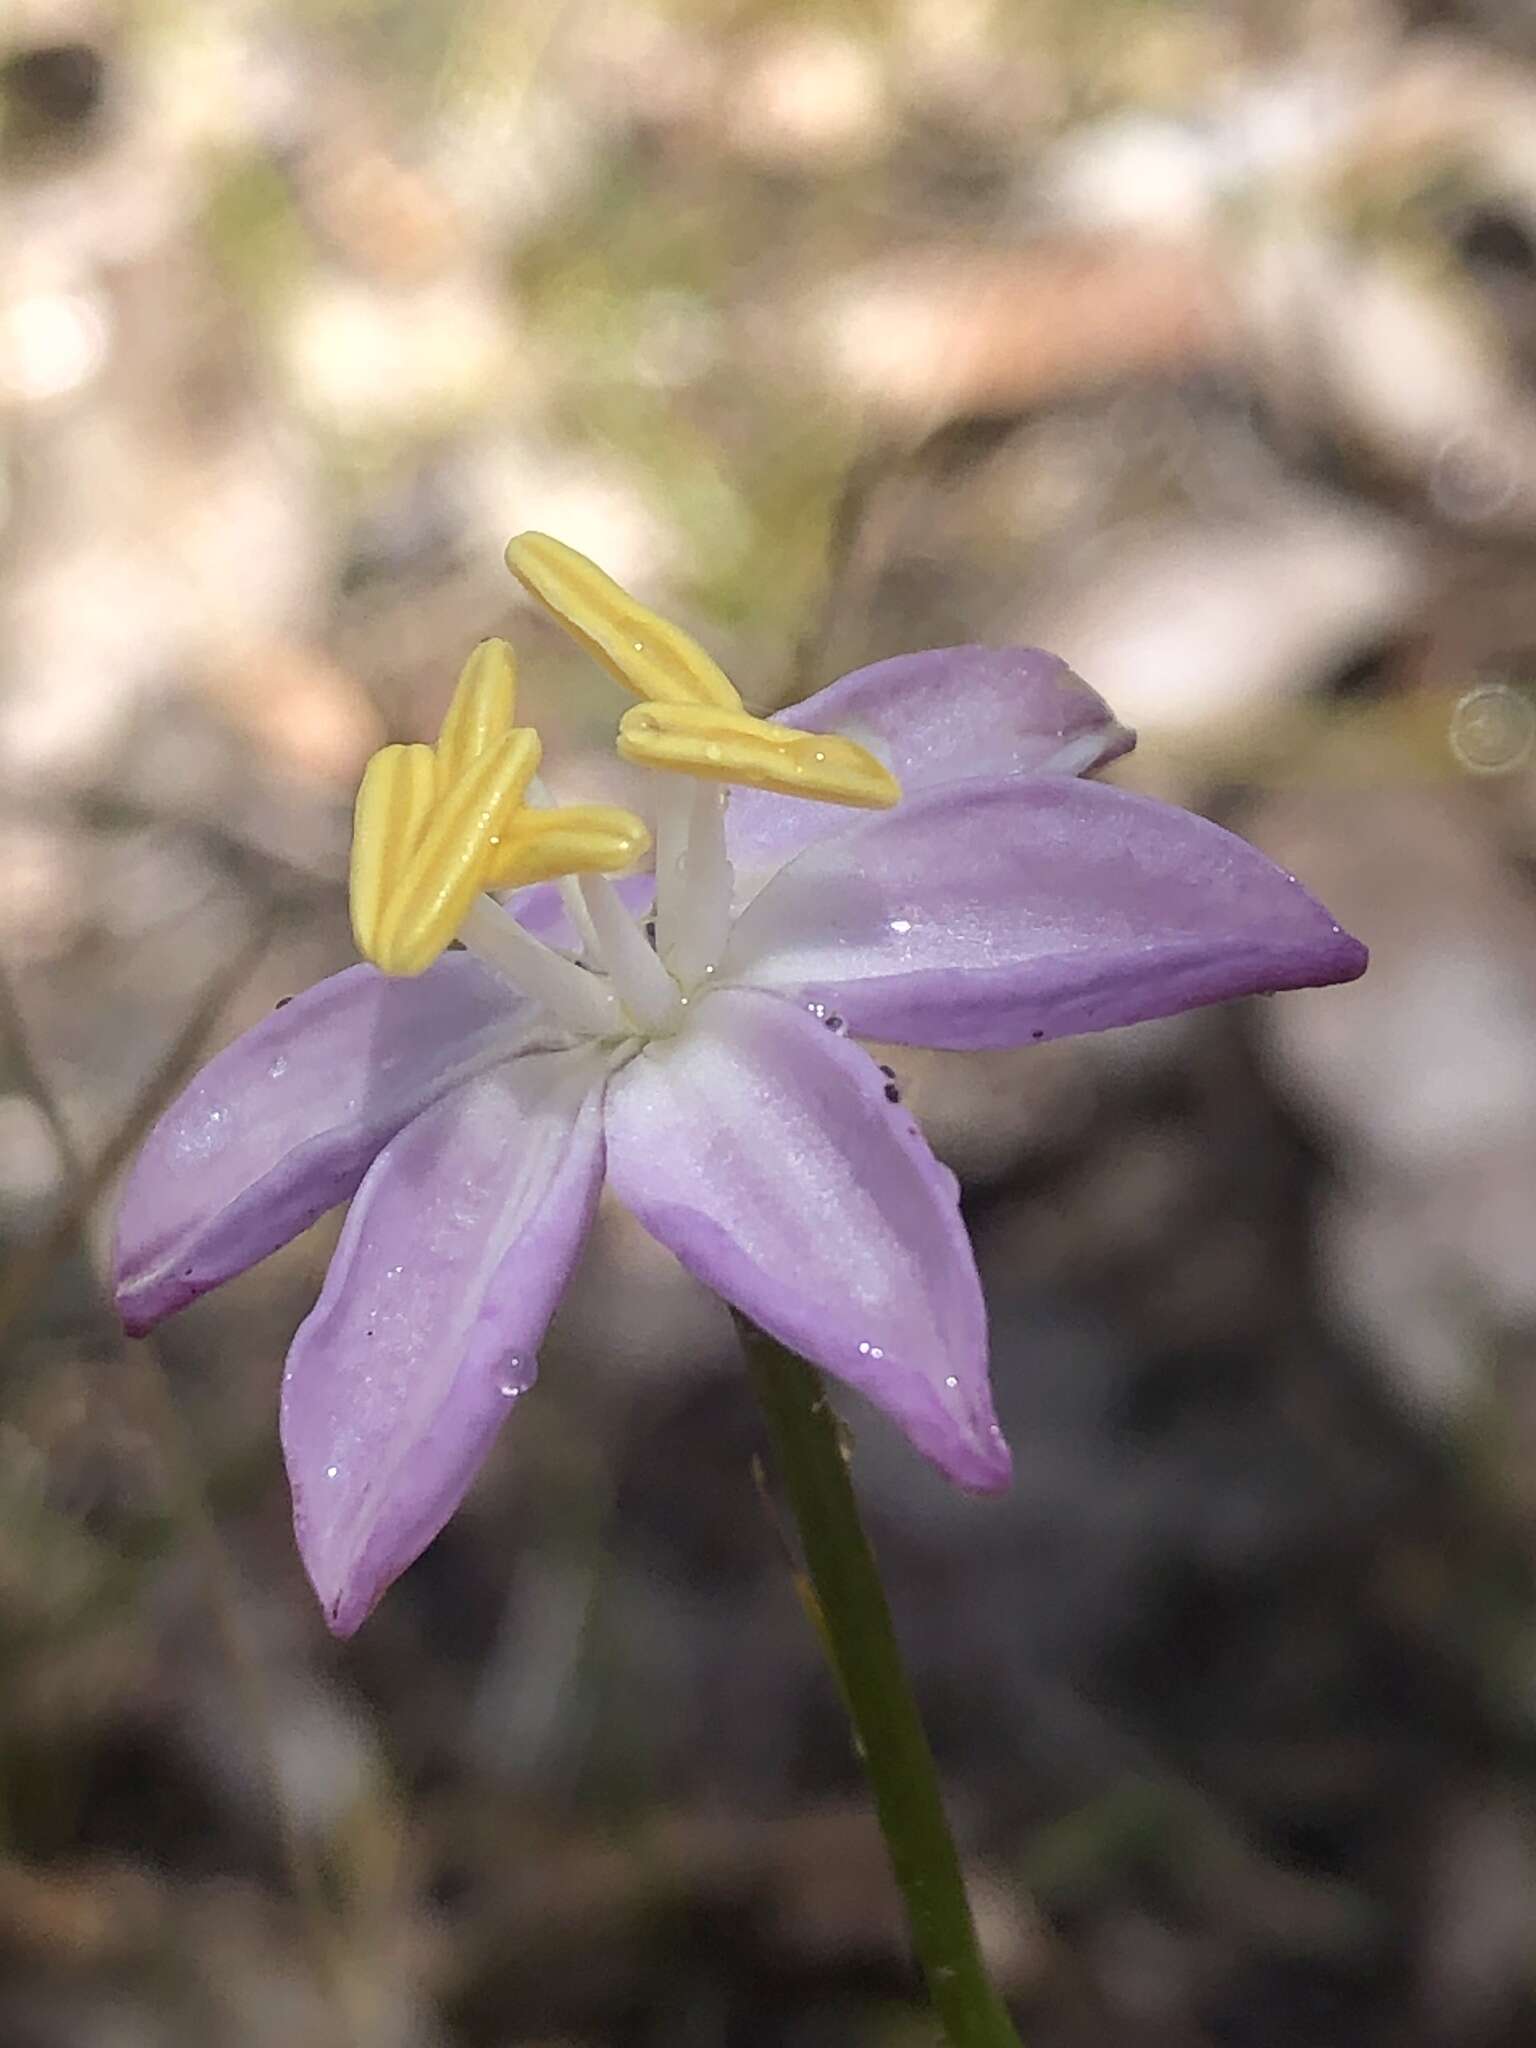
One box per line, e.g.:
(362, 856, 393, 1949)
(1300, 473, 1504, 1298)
(606, 989, 1010, 1491)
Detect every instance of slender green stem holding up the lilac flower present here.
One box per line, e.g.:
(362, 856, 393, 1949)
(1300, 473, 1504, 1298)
(737, 1317, 1020, 2048)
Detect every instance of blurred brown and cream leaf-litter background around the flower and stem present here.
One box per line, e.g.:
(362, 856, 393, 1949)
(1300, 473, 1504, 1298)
(0, 0, 1536, 2048)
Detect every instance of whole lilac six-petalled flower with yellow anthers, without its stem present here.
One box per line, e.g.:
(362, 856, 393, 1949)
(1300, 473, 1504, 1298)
(117, 535, 1366, 1634)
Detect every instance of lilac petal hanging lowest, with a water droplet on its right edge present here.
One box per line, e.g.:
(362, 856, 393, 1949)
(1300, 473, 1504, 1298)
(283, 1047, 606, 1636)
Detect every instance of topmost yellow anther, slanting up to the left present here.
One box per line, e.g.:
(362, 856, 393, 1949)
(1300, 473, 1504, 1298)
(506, 532, 741, 711)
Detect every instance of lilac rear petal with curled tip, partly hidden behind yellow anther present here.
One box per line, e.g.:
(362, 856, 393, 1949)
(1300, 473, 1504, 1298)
(727, 647, 1137, 895)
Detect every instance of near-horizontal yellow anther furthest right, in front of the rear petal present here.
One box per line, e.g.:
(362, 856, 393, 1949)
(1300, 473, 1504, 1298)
(618, 705, 901, 811)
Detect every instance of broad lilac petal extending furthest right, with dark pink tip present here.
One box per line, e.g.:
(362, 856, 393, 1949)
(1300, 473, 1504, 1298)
(721, 776, 1366, 1051)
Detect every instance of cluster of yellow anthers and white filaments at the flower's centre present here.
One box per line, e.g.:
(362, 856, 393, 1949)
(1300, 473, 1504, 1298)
(350, 535, 901, 1040)
